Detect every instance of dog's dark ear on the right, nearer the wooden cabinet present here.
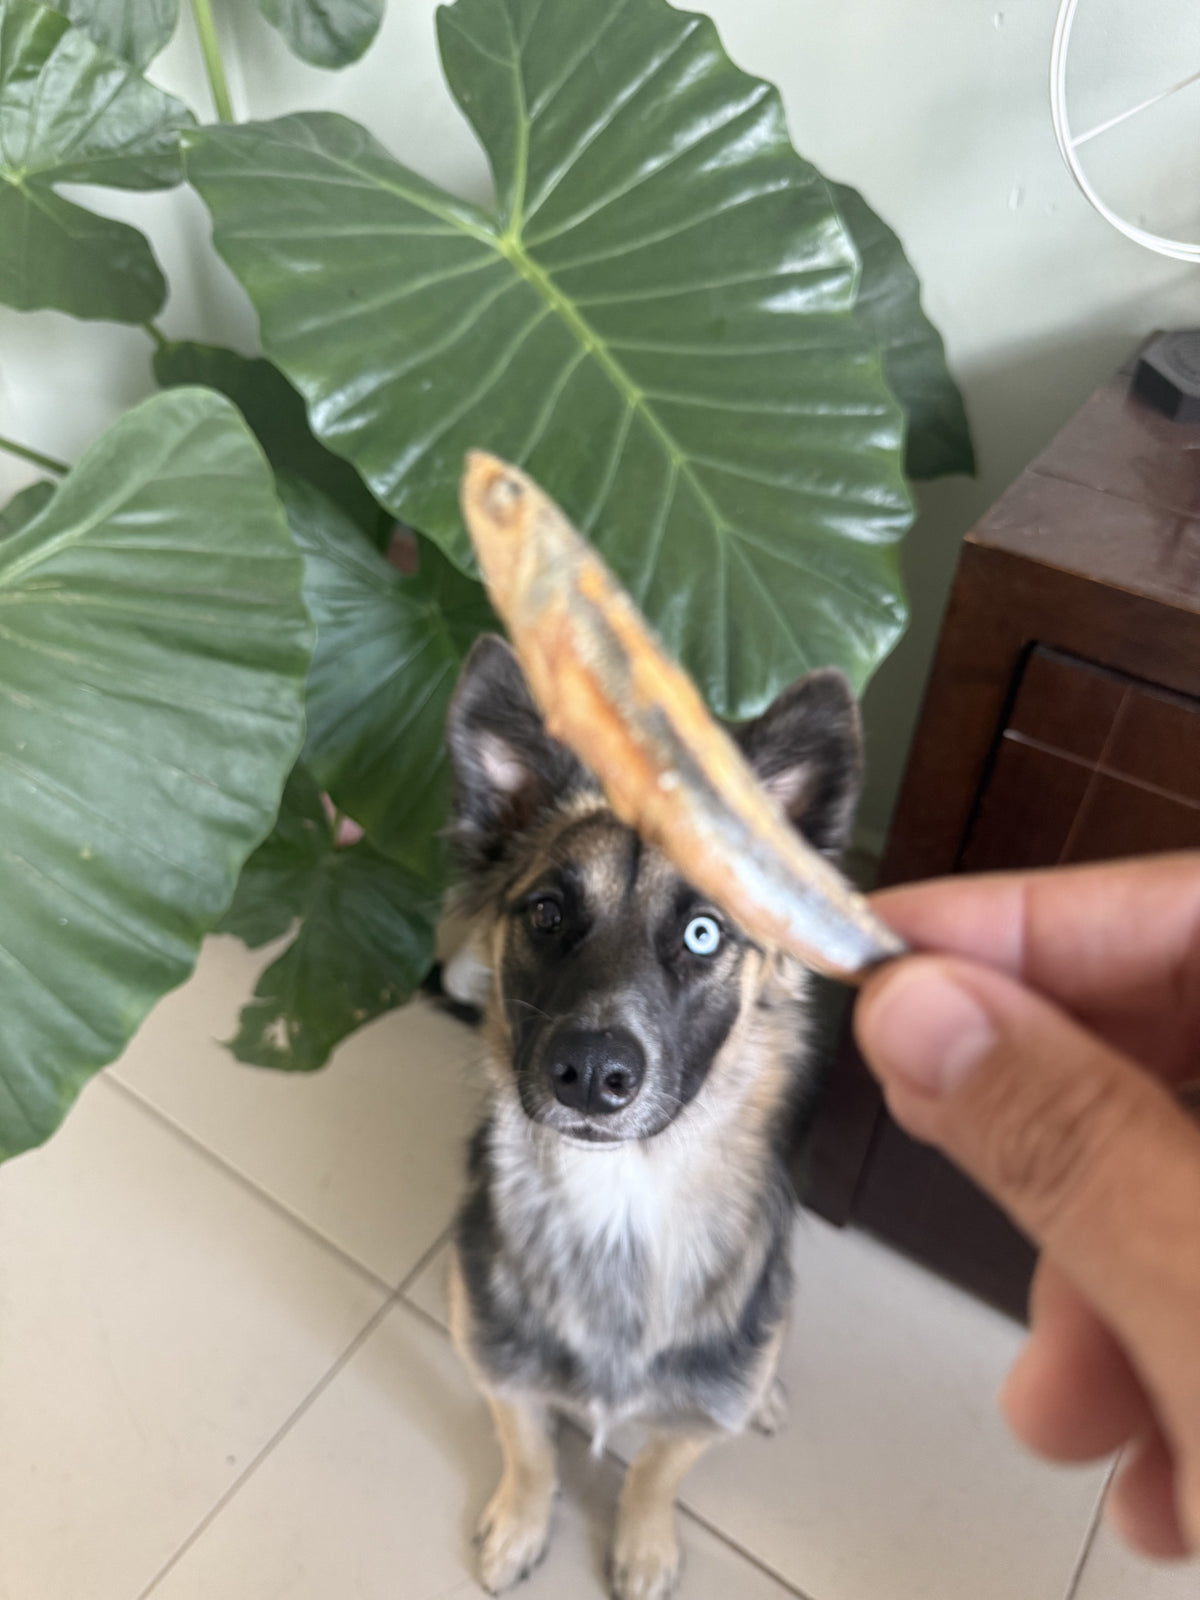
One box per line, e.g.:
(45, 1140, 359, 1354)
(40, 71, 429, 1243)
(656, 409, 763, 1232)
(730, 667, 862, 856)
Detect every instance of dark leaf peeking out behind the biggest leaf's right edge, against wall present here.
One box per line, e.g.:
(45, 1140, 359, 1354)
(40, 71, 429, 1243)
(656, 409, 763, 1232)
(830, 184, 974, 478)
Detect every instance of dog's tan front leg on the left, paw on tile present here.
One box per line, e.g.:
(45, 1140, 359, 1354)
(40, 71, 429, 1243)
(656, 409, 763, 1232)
(477, 1390, 558, 1595)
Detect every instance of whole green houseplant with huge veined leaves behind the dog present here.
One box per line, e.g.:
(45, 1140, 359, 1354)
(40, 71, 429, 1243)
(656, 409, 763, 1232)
(0, 0, 971, 1154)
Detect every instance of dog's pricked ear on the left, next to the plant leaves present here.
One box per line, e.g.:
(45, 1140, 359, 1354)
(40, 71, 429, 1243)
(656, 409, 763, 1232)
(446, 634, 584, 869)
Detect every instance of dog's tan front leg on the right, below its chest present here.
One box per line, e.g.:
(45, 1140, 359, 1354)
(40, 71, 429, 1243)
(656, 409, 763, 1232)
(613, 1434, 712, 1600)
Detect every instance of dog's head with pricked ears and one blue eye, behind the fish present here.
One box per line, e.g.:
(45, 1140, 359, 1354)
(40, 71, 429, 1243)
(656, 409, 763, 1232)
(448, 637, 862, 1144)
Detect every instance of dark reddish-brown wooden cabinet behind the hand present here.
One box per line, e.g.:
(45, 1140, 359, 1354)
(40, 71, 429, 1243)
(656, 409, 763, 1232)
(803, 344, 1200, 1315)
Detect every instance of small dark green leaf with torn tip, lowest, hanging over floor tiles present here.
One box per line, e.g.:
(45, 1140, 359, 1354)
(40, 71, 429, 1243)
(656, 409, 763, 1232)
(226, 771, 440, 1072)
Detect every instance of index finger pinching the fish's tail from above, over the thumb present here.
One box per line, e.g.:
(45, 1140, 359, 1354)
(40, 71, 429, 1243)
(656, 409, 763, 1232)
(872, 851, 1200, 1078)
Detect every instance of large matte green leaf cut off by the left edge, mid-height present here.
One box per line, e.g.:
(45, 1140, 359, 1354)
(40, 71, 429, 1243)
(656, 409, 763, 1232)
(0, 389, 310, 1155)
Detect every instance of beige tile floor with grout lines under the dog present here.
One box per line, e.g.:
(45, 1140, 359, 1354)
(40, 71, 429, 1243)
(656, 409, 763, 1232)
(0, 941, 1200, 1600)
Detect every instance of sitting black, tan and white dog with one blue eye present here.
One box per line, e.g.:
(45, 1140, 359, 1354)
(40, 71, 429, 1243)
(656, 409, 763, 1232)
(448, 635, 862, 1600)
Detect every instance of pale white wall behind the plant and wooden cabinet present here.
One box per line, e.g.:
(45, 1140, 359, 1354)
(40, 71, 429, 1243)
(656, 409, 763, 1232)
(0, 0, 1200, 842)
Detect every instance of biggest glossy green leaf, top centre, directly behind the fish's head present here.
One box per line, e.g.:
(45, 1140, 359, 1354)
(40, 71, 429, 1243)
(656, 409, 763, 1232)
(186, 0, 910, 715)
